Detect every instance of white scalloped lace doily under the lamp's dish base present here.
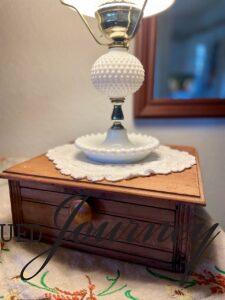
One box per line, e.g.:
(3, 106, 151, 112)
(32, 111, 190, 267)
(46, 144, 196, 182)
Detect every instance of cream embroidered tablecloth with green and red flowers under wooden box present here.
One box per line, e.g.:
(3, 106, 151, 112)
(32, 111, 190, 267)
(0, 159, 225, 300)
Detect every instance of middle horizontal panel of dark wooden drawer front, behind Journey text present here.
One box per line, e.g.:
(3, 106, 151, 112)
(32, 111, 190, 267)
(22, 200, 174, 253)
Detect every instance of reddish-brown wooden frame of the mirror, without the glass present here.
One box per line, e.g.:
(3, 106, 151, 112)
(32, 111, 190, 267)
(134, 17, 225, 118)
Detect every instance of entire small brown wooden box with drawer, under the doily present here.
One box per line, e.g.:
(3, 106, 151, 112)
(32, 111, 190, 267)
(1, 147, 205, 272)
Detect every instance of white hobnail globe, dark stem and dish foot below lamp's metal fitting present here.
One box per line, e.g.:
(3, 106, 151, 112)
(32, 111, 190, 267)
(75, 38, 159, 164)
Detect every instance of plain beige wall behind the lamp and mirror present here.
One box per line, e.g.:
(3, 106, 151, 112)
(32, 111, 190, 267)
(0, 0, 225, 226)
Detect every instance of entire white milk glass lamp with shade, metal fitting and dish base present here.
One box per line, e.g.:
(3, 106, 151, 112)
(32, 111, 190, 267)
(60, 0, 175, 164)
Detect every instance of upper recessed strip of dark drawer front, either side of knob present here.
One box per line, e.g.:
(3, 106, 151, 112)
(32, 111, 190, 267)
(21, 188, 175, 226)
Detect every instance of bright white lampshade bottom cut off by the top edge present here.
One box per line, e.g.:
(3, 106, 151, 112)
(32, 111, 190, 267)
(63, 0, 175, 17)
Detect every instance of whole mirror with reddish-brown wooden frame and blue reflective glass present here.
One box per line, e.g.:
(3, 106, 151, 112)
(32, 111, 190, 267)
(134, 0, 225, 118)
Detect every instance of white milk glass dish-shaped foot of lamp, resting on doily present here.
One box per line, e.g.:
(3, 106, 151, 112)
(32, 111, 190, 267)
(75, 129, 159, 164)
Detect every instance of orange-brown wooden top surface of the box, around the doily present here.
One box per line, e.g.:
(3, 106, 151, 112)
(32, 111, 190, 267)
(0, 146, 206, 205)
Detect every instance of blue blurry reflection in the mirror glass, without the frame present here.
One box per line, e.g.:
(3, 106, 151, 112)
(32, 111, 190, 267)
(154, 0, 225, 99)
